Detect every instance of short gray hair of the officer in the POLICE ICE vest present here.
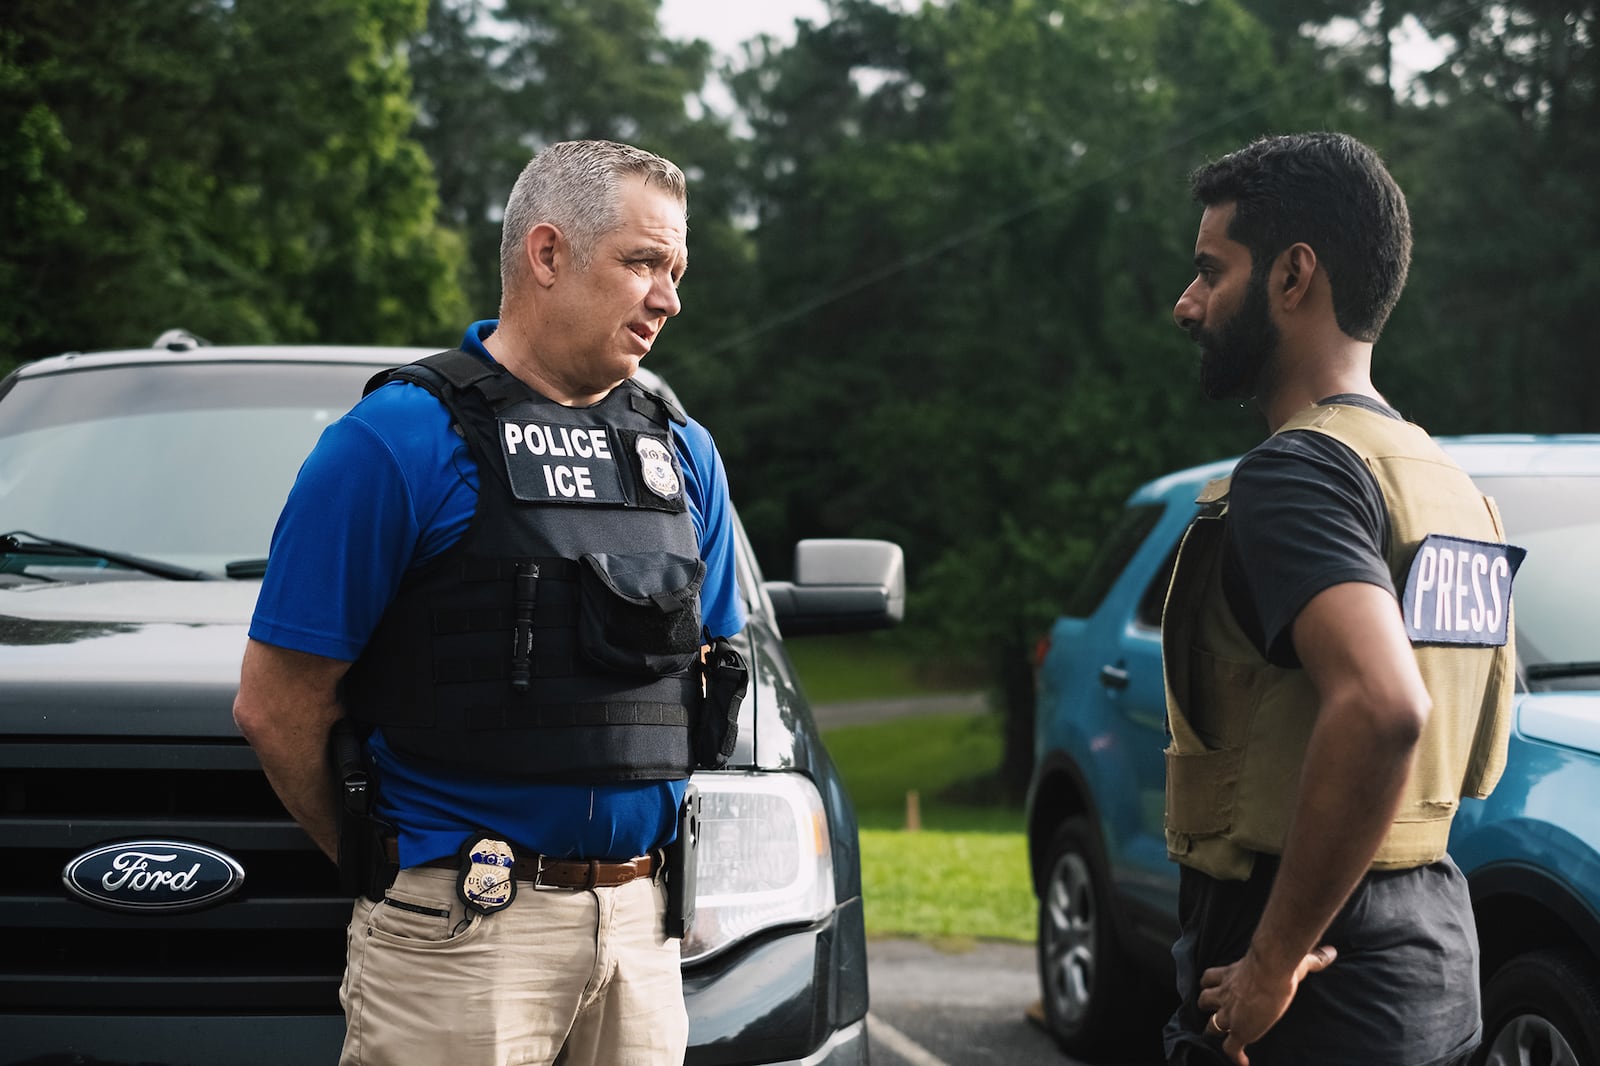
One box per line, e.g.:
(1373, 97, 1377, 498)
(501, 141, 688, 291)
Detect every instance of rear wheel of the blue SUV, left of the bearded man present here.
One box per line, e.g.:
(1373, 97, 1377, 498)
(1037, 818, 1160, 1058)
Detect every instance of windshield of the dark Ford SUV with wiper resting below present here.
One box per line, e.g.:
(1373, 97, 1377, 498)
(0, 363, 378, 576)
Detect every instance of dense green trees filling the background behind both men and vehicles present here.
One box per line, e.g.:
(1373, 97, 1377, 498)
(0, 0, 1600, 779)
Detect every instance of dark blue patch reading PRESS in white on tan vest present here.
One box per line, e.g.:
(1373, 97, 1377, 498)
(1400, 533, 1528, 648)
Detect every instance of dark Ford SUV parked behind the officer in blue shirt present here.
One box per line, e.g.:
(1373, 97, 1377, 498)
(0, 335, 904, 1066)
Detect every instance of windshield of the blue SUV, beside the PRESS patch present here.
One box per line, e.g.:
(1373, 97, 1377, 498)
(1475, 475, 1600, 688)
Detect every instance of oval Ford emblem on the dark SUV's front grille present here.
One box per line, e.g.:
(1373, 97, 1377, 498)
(61, 840, 245, 914)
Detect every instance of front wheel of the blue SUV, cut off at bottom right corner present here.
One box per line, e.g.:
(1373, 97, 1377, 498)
(1472, 949, 1600, 1066)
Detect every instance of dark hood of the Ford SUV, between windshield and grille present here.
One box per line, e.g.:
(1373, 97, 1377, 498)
(0, 579, 252, 736)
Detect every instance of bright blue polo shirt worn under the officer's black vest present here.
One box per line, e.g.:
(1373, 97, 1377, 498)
(250, 320, 744, 866)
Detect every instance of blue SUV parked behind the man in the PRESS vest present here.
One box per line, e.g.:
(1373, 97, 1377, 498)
(1027, 435, 1600, 1066)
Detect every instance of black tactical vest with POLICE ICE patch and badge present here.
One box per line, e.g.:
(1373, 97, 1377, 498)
(341, 351, 706, 783)
